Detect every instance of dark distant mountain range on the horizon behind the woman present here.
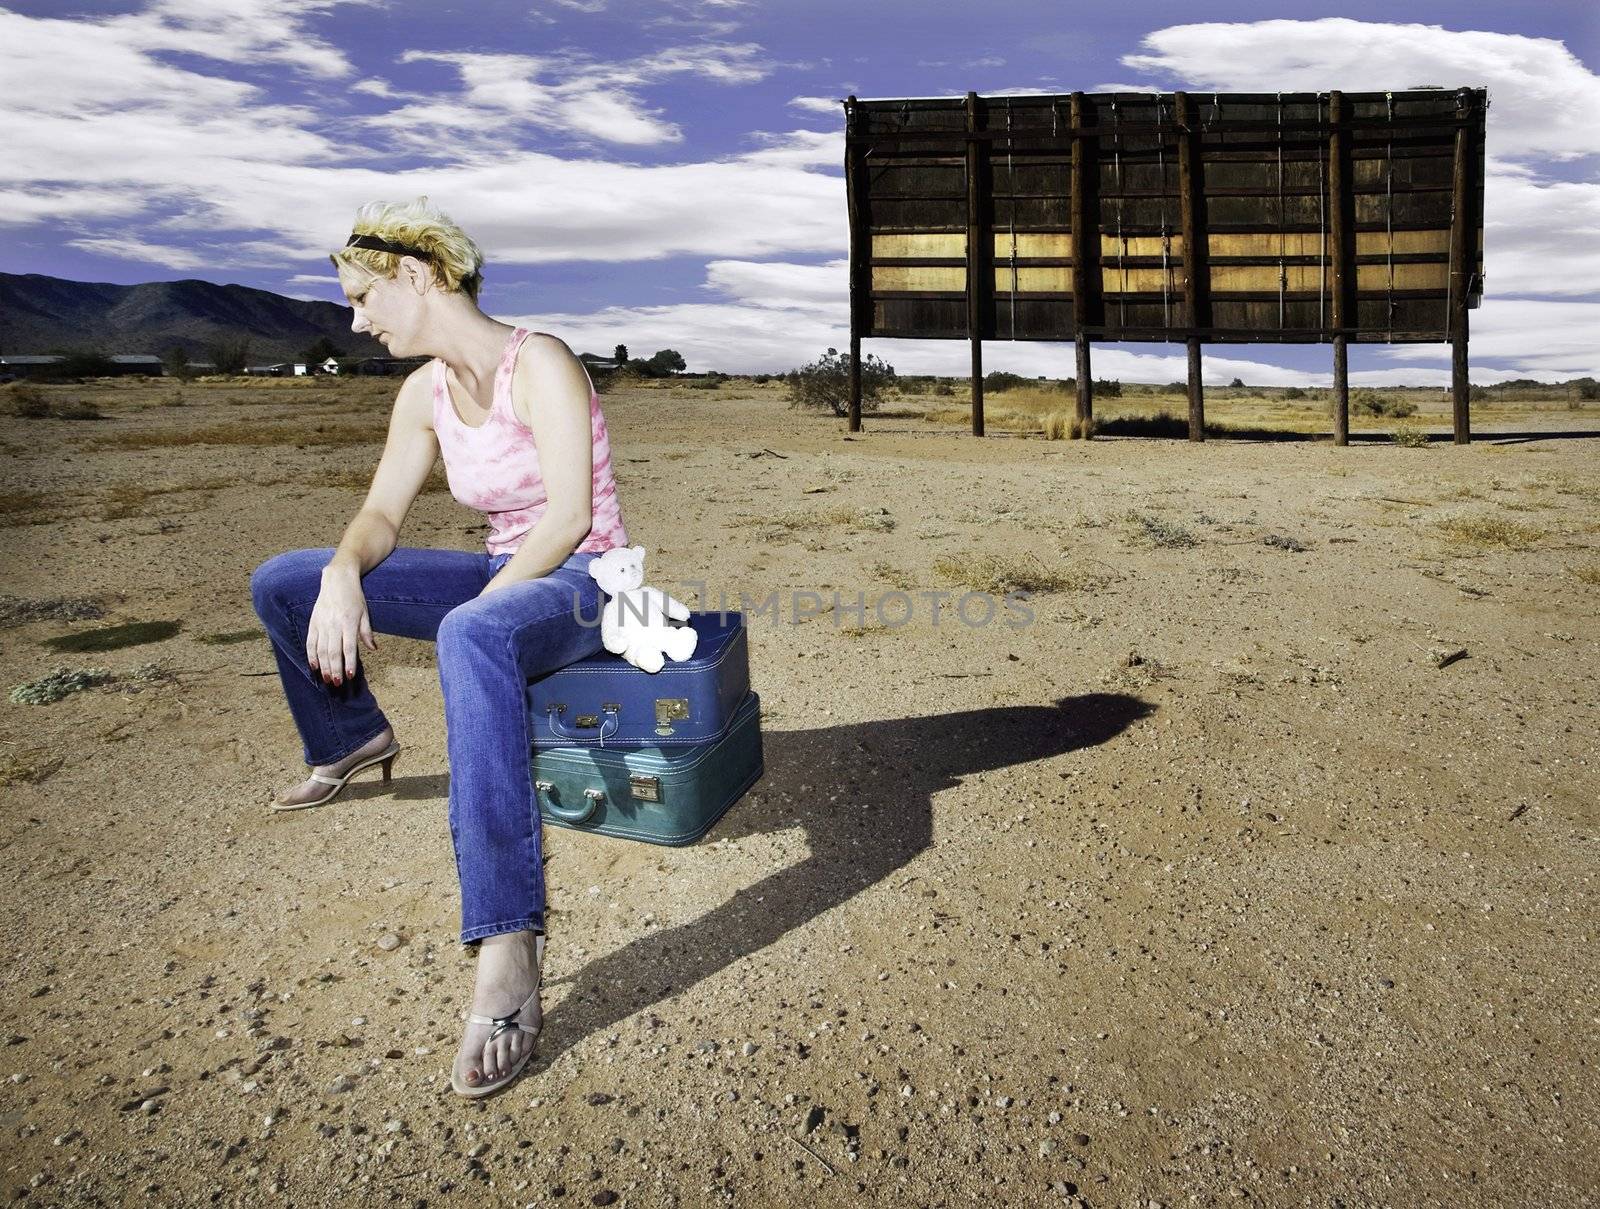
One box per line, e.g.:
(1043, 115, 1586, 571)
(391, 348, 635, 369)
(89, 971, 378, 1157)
(0, 273, 387, 363)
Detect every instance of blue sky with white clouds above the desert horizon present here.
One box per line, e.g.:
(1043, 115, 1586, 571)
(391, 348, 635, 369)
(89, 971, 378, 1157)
(9, 0, 1600, 384)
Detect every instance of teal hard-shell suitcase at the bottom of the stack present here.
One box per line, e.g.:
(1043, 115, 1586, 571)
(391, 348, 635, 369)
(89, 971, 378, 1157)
(533, 692, 765, 846)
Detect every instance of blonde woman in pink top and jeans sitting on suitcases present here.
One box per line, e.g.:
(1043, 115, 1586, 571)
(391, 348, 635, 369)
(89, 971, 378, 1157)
(251, 198, 627, 1097)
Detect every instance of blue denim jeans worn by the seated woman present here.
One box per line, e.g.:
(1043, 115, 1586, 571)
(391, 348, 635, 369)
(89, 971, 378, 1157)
(250, 547, 600, 945)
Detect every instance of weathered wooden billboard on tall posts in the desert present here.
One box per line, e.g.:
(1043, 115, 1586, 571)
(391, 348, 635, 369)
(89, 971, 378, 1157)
(845, 88, 1488, 443)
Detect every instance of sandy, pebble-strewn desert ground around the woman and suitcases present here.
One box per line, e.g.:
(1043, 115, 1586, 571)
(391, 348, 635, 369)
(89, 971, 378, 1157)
(0, 372, 1600, 1209)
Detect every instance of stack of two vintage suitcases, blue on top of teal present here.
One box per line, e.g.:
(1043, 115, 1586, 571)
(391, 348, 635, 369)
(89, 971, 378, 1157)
(528, 612, 763, 844)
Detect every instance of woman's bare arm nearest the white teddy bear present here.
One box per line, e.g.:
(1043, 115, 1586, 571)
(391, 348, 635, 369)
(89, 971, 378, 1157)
(483, 333, 594, 592)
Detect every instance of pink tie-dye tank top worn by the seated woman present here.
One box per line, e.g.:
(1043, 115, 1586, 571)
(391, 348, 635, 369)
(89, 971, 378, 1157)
(434, 328, 627, 555)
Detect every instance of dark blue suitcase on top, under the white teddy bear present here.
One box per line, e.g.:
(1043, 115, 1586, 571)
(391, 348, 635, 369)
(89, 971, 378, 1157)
(528, 612, 750, 750)
